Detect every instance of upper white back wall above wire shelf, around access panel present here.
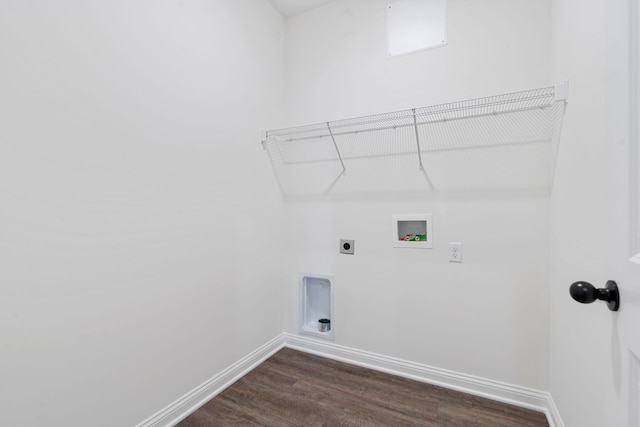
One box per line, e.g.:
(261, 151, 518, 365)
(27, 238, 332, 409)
(287, 0, 560, 125)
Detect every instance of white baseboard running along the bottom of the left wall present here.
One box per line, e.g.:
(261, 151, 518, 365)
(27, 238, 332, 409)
(136, 335, 284, 427)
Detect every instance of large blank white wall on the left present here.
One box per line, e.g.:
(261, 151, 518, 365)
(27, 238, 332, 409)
(0, 0, 285, 426)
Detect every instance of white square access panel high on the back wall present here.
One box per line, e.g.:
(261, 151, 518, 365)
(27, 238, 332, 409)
(387, 0, 447, 57)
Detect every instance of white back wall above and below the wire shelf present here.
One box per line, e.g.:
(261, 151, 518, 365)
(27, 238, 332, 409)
(285, 0, 553, 390)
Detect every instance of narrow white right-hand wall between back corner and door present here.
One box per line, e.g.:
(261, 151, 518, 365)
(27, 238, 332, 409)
(550, 1, 611, 427)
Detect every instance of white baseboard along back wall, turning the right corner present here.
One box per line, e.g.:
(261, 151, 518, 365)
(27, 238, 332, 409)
(284, 334, 564, 427)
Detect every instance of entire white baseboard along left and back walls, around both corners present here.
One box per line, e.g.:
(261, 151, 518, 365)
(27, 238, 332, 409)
(136, 333, 564, 427)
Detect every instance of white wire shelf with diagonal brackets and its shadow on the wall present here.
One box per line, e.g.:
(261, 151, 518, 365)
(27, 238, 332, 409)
(262, 83, 567, 199)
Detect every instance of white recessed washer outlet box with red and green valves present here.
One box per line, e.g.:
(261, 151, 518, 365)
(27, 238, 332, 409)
(391, 214, 433, 249)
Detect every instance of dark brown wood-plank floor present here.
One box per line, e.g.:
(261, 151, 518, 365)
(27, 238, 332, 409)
(178, 348, 549, 427)
